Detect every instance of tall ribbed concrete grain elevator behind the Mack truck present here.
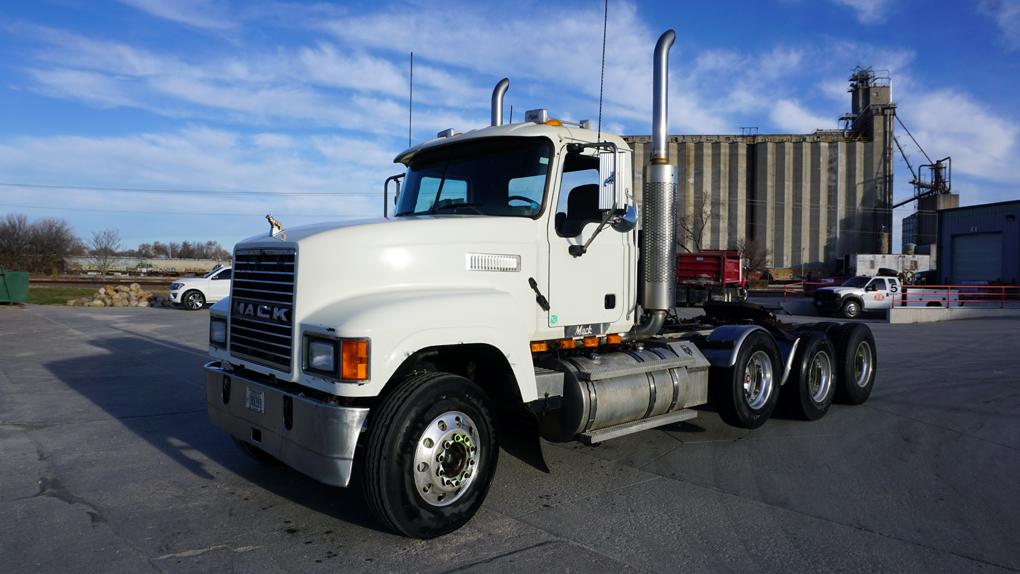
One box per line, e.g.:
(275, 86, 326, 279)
(624, 69, 896, 270)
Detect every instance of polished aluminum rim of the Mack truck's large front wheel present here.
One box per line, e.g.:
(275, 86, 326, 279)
(411, 411, 481, 507)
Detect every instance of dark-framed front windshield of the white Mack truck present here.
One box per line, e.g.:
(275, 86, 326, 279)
(397, 138, 553, 217)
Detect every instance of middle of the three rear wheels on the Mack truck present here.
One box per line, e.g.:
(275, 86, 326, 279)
(780, 330, 838, 420)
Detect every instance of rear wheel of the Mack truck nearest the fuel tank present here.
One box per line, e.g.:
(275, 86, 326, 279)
(709, 330, 783, 428)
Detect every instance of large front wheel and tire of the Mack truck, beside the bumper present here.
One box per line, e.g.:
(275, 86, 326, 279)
(363, 372, 499, 538)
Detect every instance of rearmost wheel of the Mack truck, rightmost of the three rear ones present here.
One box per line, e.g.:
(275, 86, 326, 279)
(835, 323, 878, 405)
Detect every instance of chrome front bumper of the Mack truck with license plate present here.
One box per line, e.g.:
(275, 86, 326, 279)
(205, 361, 368, 486)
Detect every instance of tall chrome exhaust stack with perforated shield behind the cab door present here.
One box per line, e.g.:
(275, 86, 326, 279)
(631, 30, 676, 337)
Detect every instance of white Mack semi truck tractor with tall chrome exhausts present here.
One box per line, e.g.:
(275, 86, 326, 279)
(205, 31, 877, 538)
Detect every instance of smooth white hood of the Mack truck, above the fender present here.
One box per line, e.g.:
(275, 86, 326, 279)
(236, 215, 548, 320)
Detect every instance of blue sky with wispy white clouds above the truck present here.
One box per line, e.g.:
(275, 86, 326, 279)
(0, 0, 1020, 252)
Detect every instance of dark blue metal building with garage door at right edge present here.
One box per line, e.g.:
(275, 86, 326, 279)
(936, 201, 1020, 284)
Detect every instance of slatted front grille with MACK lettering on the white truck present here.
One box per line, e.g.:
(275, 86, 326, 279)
(230, 249, 297, 372)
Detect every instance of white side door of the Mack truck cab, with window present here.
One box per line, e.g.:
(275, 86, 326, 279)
(548, 154, 629, 336)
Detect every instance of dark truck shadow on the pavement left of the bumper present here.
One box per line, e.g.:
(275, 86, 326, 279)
(45, 331, 381, 530)
